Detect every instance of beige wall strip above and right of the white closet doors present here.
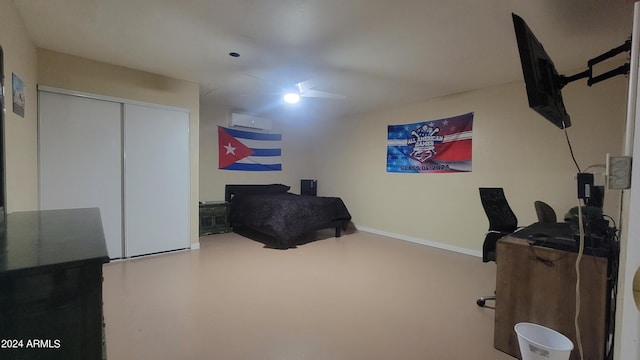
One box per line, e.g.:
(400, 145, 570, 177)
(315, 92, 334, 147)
(38, 49, 200, 243)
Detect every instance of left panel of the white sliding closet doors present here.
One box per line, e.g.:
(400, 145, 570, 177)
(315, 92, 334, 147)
(38, 91, 123, 258)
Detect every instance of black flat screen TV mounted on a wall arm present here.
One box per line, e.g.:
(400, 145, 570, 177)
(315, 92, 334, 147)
(511, 14, 571, 129)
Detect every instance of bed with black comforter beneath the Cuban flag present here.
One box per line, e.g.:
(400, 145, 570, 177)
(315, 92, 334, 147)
(225, 184, 351, 249)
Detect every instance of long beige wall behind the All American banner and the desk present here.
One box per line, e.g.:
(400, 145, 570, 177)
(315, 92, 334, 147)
(312, 77, 627, 254)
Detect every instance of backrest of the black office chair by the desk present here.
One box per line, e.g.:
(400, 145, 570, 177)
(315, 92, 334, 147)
(479, 188, 518, 233)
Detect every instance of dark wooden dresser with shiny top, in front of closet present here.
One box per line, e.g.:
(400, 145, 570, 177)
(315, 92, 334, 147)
(0, 208, 109, 360)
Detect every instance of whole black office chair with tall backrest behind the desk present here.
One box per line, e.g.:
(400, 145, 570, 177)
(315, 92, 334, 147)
(476, 188, 518, 307)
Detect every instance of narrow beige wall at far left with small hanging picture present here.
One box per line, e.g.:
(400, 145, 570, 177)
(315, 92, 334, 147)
(0, 1, 38, 212)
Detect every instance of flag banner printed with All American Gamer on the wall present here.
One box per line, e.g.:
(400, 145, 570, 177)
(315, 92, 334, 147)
(387, 113, 473, 173)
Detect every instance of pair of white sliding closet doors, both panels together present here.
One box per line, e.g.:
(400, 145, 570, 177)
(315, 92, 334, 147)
(38, 88, 190, 259)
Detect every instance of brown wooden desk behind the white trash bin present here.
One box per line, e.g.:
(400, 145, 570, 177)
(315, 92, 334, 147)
(494, 236, 608, 360)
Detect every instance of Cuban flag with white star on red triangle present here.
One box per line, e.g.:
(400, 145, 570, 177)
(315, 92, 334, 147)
(218, 126, 282, 171)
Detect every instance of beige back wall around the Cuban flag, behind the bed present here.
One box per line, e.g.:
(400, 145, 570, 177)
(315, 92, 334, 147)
(200, 102, 312, 201)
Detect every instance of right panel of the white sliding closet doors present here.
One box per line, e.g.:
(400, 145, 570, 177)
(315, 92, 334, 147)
(124, 104, 190, 256)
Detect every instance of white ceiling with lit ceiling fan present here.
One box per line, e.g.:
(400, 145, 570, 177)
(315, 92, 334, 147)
(14, 0, 633, 118)
